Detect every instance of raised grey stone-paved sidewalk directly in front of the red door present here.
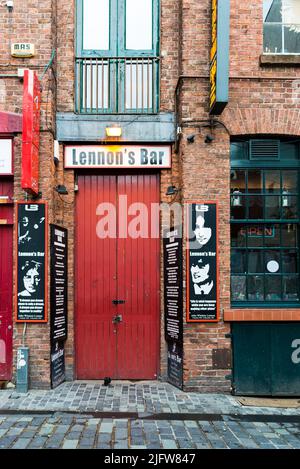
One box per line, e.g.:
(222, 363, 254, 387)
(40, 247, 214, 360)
(0, 381, 300, 416)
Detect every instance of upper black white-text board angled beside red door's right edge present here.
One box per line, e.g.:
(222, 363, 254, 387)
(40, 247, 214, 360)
(163, 228, 183, 344)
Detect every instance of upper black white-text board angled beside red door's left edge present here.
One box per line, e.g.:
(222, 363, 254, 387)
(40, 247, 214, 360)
(50, 225, 68, 344)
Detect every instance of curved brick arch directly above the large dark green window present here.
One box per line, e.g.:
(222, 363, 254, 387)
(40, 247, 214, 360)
(220, 107, 300, 136)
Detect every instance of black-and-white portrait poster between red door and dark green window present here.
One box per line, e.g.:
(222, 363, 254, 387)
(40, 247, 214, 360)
(187, 202, 219, 322)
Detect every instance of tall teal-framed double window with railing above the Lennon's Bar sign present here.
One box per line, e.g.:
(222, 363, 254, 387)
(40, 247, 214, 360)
(76, 0, 159, 114)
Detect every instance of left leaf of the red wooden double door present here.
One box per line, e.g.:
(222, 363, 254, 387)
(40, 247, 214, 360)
(76, 175, 116, 379)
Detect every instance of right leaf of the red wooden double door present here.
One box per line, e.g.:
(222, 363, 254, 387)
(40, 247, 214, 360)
(117, 174, 159, 379)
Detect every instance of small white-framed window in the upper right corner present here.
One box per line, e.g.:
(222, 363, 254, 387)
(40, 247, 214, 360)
(263, 0, 300, 54)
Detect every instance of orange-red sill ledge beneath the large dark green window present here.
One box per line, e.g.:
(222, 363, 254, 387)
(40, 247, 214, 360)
(224, 308, 300, 322)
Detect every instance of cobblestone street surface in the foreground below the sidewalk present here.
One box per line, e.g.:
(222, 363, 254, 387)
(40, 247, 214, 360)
(0, 413, 300, 450)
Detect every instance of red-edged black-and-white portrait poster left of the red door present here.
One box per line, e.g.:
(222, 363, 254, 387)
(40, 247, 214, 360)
(16, 202, 47, 322)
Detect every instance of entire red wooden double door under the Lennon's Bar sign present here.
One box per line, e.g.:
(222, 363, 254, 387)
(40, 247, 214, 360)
(75, 174, 160, 379)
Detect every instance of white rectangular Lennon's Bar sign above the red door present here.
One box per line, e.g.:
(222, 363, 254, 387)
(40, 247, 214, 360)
(65, 145, 171, 169)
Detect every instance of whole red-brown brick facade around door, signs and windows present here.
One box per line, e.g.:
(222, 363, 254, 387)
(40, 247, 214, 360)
(0, 0, 300, 392)
